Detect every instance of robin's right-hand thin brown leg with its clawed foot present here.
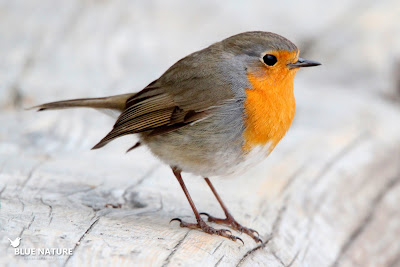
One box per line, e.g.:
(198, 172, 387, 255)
(200, 178, 261, 242)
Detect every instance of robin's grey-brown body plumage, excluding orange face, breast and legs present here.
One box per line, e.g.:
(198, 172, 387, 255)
(32, 32, 297, 176)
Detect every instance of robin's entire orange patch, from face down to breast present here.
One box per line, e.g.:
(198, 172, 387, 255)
(243, 51, 298, 152)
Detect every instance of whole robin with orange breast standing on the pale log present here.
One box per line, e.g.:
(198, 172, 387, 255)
(33, 31, 321, 245)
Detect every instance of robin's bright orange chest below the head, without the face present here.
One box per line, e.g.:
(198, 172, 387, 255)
(243, 84, 296, 153)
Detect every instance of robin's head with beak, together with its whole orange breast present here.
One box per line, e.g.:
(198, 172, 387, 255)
(216, 32, 320, 152)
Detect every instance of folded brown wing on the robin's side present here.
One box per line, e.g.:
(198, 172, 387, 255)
(93, 49, 234, 149)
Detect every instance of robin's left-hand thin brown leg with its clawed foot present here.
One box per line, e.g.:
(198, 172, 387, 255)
(171, 167, 243, 243)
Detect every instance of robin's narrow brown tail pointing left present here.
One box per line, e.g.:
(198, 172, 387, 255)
(29, 93, 136, 112)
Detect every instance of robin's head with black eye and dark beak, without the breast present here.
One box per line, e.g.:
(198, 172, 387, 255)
(219, 31, 321, 90)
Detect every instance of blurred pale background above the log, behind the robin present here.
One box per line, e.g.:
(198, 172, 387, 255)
(0, 0, 400, 153)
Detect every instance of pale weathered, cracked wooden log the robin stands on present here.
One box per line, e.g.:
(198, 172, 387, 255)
(0, 90, 400, 266)
